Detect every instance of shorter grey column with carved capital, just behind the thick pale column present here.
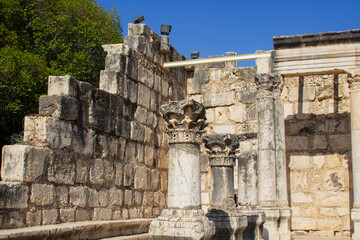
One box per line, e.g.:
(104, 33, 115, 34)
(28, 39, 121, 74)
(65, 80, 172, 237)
(203, 134, 248, 240)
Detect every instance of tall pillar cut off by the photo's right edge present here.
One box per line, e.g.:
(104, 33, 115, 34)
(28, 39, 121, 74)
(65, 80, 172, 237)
(349, 71, 360, 240)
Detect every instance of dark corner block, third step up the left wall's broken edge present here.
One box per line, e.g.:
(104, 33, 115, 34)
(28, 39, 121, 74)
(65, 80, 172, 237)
(39, 95, 80, 120)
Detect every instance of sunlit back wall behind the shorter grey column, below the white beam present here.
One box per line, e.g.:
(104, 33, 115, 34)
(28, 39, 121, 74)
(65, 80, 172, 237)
(187, 58, 257, 210)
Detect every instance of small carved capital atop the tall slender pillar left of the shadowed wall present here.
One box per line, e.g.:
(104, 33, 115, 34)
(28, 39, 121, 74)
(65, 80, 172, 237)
(255, 73, 284, 98)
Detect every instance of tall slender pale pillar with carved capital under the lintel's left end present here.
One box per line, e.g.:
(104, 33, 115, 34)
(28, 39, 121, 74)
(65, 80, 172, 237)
(255, 73, 291, 240)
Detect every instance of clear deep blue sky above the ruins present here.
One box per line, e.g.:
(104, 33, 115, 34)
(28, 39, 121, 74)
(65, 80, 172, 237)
(96, 0, 360, 63)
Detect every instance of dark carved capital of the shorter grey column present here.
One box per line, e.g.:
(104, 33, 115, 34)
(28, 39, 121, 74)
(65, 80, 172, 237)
(203, 134, 239, 166)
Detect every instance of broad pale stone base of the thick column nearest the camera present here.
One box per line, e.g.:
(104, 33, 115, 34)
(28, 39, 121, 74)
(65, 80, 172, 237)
(149, 209, 215, 240)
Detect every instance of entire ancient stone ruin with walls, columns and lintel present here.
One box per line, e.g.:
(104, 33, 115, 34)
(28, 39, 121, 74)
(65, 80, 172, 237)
(0, 24, 360, 240)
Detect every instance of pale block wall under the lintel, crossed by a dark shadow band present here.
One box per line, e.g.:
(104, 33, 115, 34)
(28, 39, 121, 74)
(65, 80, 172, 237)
(282, 74, 352, 236)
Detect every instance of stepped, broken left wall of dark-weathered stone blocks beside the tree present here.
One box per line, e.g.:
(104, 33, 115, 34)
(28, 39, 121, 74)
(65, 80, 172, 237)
(0, 24, 186, 228)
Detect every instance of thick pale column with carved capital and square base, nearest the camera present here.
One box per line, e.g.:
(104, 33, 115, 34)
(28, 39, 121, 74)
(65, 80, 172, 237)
(149, 99, 215, 240)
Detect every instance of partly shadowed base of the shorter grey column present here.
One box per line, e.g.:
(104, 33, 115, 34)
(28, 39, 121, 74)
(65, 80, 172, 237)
(206, 209, 248, 240)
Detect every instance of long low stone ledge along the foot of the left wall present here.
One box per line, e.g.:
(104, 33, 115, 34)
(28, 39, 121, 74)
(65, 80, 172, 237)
(0, 218, 154, 240)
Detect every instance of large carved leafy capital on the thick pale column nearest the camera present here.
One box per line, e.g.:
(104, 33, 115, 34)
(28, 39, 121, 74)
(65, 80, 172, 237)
(161, 99, 206, 144)
